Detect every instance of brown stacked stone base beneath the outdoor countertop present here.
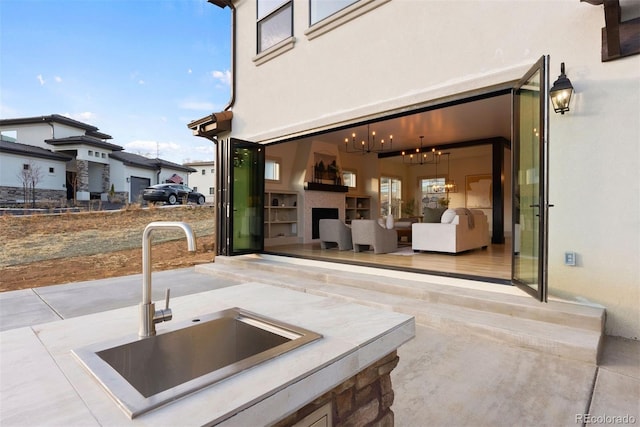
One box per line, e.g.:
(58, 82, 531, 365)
(275, 351, 399, 427)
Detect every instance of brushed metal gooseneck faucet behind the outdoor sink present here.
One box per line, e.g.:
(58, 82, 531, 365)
(138, 221, 196, 338)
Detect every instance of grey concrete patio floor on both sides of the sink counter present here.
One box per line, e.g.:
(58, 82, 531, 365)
(0, 268, 640, 427)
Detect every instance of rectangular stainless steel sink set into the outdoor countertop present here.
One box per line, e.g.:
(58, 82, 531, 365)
(73, 308, 321, 418)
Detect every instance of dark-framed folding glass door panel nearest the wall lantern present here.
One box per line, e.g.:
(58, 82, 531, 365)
(512, 56, 548, 301)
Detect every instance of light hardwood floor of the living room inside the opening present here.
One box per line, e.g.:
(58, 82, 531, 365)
(265, 240, 511, 283)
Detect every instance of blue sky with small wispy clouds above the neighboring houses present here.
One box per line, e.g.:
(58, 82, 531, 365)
(0, 0, 231, 163)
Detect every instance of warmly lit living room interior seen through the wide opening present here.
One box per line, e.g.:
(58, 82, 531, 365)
(264, 91, 512, 283)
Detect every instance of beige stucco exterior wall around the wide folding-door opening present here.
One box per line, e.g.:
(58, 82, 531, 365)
(228, 0, 640, 339)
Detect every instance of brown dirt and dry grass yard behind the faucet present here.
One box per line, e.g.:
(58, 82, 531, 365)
(0, 206, 215, 292)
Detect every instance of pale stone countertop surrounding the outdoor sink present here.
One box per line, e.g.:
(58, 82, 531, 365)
(0, 283, 415, 427)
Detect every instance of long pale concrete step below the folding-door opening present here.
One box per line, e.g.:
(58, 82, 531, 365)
(196, 255, 605, 363)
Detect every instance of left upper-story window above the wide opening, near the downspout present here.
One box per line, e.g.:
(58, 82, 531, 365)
(258, 0, 293, 53)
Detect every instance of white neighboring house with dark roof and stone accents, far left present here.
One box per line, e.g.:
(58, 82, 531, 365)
(0, 114, 198, 203)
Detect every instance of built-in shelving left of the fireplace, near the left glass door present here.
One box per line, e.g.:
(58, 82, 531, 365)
(264, 191, 298, 246)
